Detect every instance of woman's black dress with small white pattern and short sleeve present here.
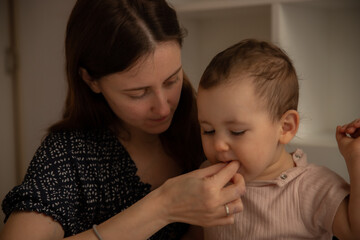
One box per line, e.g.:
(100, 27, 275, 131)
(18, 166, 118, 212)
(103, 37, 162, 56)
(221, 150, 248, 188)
(2, 129, 188, 237)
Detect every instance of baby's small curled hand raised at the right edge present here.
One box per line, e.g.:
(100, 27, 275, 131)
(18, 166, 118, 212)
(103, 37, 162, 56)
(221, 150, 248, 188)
(336, 118, 360, 162)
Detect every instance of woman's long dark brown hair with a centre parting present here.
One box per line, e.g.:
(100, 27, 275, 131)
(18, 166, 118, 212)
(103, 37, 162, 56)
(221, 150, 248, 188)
(49, 0, 204, 171)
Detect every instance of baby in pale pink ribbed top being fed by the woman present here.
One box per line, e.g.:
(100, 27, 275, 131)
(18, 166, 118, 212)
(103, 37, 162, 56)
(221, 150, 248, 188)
(197, 39, 360, 240)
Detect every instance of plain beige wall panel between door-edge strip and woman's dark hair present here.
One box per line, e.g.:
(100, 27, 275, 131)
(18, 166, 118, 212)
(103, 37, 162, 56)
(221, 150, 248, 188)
(17, 0, 74, 178)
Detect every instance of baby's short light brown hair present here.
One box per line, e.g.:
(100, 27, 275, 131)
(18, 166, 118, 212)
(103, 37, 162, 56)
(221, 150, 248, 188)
(199, 39, 299, 121)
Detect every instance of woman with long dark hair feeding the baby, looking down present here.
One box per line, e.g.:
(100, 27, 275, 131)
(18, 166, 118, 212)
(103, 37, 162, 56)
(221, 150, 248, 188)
(0, 0, 244, 240)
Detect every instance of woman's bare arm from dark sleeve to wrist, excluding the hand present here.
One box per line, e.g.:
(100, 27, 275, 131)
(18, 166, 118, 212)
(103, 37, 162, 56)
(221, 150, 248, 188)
(0, 190, 168, 240)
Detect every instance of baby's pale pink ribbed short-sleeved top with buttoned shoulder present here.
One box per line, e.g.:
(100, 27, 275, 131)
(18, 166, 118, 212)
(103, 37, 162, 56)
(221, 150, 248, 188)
(204, 149, 350, 240)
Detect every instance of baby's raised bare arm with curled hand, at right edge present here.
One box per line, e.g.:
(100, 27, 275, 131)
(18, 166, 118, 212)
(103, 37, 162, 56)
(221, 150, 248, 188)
(333, 119, 360, 239)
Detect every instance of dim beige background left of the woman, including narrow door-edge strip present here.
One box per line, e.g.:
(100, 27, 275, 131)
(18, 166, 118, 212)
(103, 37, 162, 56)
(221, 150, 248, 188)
(0, 0, 75, 227)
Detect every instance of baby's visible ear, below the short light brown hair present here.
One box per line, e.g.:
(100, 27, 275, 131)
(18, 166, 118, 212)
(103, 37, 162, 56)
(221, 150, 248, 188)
(279, 110, 300, 144)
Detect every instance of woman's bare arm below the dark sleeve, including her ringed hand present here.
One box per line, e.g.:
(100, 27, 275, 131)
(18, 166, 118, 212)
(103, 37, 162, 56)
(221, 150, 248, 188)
(0, 162, 245, 240)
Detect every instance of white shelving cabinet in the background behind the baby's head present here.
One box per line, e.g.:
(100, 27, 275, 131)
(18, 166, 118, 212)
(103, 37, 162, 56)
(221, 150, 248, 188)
(170, 0, 360, 180)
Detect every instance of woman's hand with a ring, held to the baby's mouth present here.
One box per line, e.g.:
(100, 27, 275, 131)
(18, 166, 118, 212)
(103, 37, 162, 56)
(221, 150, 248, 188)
(160, 161, 245, 227)
